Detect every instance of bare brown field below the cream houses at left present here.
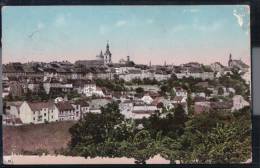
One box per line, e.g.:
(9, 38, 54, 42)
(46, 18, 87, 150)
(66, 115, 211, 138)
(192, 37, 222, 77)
(3, 121, 75, 155)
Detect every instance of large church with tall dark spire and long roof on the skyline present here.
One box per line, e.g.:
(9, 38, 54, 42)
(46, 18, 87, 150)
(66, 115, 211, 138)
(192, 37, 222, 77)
(75, 42, 112, 67)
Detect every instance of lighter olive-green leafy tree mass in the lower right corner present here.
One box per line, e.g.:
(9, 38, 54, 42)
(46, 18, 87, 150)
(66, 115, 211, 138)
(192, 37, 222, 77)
(179, 109, 251, 163)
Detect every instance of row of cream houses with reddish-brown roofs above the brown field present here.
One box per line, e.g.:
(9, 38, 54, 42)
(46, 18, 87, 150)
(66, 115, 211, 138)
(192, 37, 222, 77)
(3, 99, 111, 125)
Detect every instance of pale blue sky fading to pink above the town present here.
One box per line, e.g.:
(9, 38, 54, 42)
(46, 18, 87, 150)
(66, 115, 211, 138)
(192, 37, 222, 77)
(2, 5, 250, 65)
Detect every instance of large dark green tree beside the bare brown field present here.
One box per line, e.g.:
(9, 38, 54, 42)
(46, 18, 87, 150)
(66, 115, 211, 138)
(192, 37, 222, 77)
(69, 102, 125, 157)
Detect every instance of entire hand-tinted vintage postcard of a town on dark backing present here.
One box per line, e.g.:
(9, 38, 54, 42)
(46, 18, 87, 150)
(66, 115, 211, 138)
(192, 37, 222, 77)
(1, 5, 252, 164)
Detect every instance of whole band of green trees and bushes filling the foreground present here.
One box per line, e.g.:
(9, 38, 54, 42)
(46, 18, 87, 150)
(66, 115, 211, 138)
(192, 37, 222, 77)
(68, 100, 251, 164)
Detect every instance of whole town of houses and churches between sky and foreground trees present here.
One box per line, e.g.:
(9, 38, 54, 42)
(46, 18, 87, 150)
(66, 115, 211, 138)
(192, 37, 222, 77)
(2, 43, 250, 127)
